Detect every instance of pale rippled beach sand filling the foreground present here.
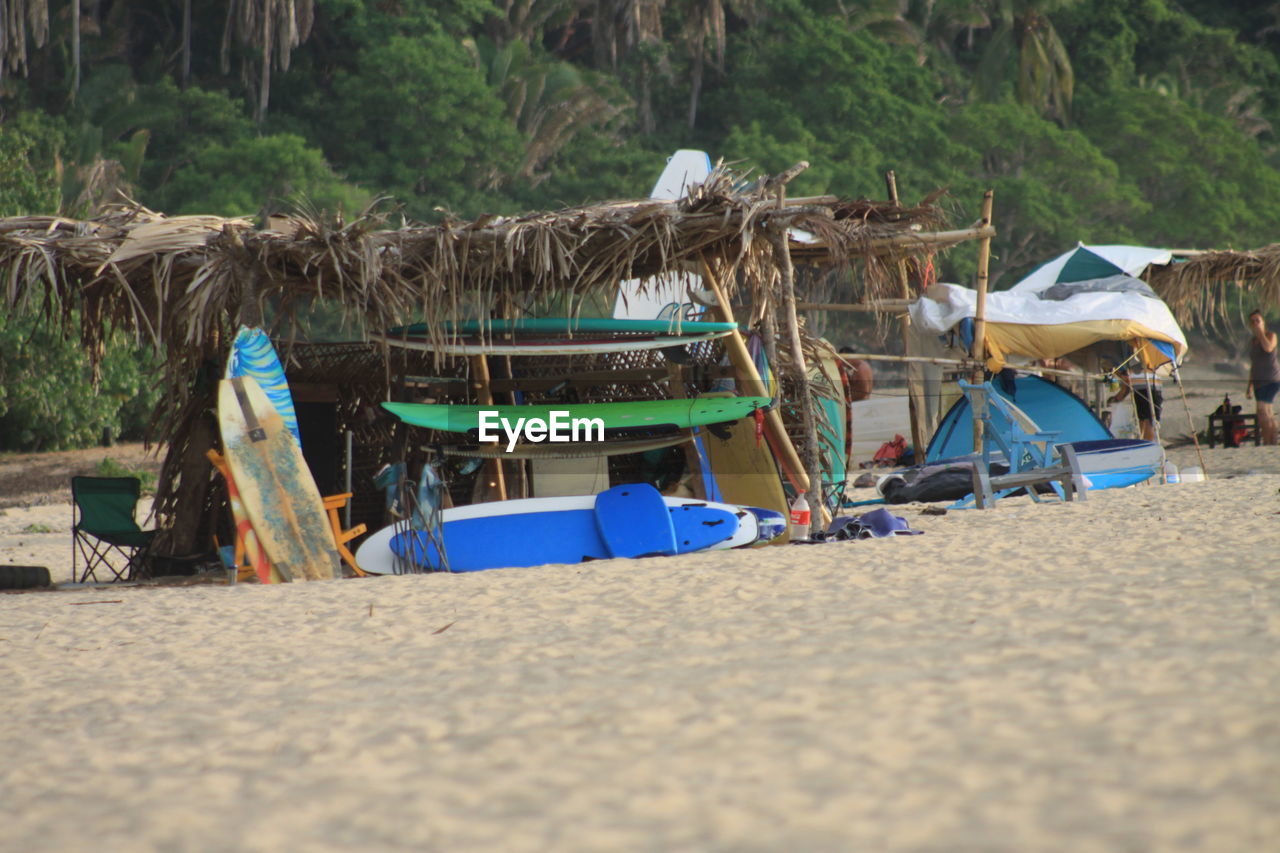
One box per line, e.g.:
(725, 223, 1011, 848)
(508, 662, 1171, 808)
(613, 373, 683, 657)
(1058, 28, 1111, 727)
(0, 461, 1280, 852)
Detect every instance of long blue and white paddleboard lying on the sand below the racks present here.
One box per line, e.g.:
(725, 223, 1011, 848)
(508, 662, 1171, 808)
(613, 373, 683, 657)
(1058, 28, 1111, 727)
(356, 485, 786, 574)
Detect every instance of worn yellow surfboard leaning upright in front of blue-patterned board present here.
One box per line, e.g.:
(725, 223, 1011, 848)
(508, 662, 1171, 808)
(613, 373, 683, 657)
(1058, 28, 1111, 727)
(218, 377, 339, 580)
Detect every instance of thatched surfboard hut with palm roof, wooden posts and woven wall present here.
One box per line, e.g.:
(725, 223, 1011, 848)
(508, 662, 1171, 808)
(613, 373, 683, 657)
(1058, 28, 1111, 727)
(0, 165, 973, 568)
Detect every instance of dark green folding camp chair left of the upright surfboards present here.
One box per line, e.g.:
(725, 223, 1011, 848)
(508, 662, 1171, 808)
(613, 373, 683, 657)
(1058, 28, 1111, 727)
(72, 476, 156, 583)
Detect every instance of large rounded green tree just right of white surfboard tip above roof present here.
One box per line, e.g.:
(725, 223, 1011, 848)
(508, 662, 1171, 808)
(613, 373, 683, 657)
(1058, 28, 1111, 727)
(704, 18, 972, 199)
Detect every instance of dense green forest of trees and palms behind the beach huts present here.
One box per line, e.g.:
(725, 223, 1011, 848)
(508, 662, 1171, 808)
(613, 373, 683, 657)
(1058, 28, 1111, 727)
(0, 0, 1280, 446)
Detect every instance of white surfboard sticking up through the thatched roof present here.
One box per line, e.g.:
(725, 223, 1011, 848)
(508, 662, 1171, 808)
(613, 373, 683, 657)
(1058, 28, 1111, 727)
(613, 149, 712, 320)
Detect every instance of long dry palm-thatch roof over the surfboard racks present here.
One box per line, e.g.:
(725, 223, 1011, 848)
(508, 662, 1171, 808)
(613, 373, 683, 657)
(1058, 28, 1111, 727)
(0, 169, 957, 366)
